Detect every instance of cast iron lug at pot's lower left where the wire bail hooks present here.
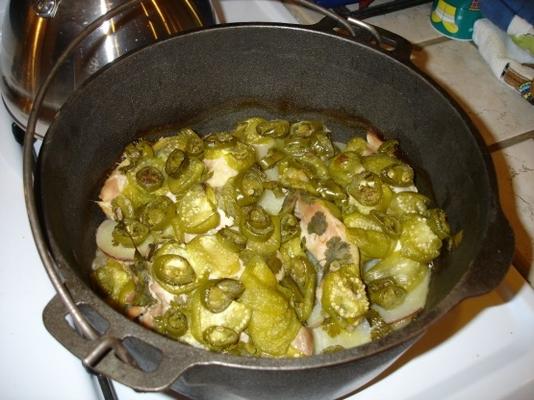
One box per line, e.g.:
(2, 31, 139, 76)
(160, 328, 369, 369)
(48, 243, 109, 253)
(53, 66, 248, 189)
(43, 295, 206, 392)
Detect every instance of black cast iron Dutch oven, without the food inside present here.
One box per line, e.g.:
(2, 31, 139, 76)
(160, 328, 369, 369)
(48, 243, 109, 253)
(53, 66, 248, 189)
(36, 24, 513, 399)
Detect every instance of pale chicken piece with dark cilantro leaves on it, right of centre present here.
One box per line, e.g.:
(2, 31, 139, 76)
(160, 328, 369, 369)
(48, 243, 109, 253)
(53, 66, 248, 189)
(295, 196, 360, 268)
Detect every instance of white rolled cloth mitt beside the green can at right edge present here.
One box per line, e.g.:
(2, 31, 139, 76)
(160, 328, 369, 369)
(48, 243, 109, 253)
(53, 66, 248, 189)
(473, 18, 534, 105)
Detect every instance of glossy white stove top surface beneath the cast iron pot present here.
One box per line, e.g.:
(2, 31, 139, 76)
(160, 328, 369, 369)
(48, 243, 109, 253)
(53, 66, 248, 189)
(0, 0, 534, 400)
